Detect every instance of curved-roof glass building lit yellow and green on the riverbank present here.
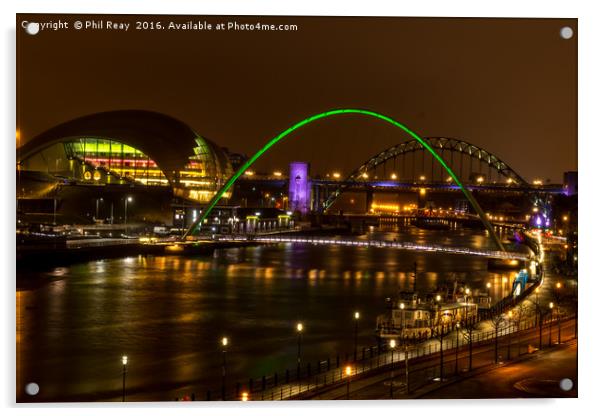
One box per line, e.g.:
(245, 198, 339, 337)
(17, 110, 232, 226)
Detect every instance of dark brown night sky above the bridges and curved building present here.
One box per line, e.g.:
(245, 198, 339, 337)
(17, 15, 577, 183)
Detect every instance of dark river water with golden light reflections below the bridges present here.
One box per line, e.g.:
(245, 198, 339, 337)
(17, 229, 511, 401)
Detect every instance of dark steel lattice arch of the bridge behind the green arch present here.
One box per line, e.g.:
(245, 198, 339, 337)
(322, 137, 528, 210)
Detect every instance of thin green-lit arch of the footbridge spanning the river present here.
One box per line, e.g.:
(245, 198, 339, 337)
(184, 108, 506, 251)
